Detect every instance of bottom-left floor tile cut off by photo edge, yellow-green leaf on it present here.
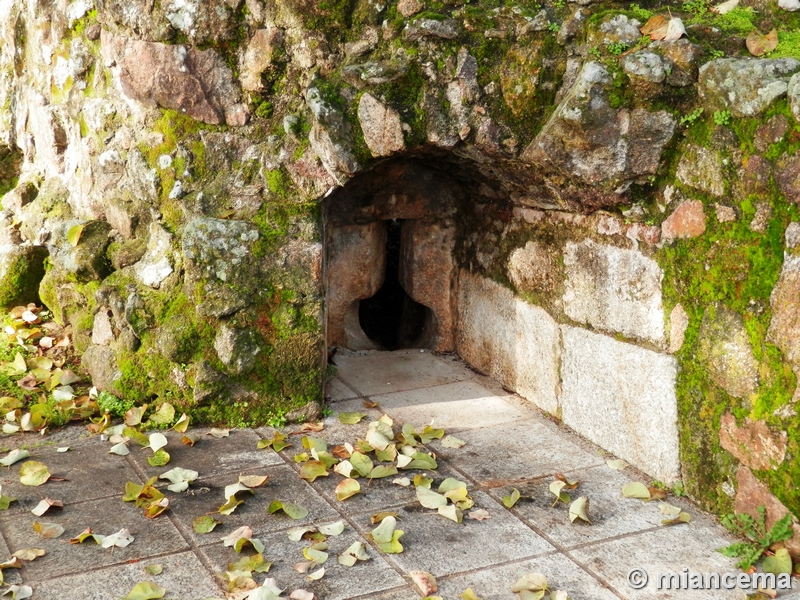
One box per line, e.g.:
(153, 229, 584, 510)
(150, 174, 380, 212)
(33, 542, 222, 600)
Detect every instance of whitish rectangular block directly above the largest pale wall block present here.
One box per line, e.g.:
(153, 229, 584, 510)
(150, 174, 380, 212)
(563, 240, 664, 344)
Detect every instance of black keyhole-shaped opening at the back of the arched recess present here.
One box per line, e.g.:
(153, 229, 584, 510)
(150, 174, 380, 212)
(358, 219, 429, 350)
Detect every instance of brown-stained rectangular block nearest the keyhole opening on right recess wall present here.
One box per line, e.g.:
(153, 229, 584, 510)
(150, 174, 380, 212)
(456, 270, 561, 414)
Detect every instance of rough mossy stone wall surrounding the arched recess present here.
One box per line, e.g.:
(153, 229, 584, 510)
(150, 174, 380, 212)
(0, 0, 800, 544)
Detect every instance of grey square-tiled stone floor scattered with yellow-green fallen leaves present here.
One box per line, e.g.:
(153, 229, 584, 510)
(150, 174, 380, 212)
(0, 350, 800, 600)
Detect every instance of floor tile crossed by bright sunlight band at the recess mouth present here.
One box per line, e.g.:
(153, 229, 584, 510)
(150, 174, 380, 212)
(371, 381, 529, 431)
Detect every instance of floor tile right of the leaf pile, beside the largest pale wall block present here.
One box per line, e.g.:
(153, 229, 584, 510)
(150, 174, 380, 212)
(430, 418, 603, 486)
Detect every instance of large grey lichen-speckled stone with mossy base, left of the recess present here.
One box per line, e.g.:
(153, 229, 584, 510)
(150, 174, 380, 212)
(182, 218, 261, 317)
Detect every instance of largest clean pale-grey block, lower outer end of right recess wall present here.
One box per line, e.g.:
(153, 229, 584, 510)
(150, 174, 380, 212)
(561, 325, 680, 482)
